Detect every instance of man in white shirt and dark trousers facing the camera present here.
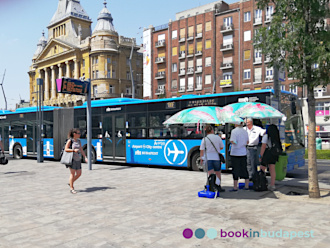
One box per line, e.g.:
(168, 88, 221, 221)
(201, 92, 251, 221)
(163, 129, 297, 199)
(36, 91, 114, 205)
(244, 118, 266, 180)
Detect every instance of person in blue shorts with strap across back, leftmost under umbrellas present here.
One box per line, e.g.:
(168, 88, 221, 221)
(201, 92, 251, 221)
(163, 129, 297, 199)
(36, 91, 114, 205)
(199, 125, 225, 192)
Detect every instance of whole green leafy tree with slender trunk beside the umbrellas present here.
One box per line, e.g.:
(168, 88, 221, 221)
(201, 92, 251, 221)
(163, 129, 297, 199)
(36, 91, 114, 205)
(255, 0, 330, 198)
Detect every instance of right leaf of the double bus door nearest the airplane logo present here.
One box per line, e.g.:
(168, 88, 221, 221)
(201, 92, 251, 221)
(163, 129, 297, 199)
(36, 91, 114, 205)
(113, 114, 126, 162)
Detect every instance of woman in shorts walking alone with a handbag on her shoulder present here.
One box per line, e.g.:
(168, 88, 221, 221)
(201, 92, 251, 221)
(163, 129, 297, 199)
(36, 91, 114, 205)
(65, 128, 87, 194)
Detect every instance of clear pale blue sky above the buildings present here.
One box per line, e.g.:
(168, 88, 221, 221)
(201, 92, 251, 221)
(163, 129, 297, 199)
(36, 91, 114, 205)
(0, 0, 239, 109)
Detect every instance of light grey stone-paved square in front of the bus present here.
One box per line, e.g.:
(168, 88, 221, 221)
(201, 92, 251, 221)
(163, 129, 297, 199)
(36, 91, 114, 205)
(0, 159, 330, 248)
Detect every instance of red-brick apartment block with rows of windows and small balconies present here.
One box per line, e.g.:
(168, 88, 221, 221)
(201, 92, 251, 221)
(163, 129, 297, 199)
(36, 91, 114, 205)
(143, 0, 302, 99)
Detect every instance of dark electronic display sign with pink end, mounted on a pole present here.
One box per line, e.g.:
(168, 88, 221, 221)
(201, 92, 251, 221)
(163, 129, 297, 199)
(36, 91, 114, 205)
(56, 77, 89, 95)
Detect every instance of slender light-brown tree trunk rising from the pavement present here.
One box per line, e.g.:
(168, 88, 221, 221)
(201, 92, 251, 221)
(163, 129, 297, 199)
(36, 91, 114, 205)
(307, 87, 320, 198)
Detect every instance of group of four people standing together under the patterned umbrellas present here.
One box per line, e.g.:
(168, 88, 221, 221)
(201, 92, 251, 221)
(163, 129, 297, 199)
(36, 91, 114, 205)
(200, 118, 281, 192)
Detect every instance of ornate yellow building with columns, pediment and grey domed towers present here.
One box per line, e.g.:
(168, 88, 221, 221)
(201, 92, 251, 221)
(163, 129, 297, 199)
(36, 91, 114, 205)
(28, 0, 142, 106)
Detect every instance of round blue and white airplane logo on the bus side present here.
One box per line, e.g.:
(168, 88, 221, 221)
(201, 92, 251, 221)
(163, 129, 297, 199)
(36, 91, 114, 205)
(164, 140, 188, 165)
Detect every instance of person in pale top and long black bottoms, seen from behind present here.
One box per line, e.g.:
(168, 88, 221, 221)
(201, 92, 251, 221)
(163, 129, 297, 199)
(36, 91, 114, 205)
(230, 122, 249, 192)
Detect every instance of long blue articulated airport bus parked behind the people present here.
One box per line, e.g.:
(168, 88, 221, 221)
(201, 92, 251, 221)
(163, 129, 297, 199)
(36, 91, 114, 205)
(0, 89, 305, 171)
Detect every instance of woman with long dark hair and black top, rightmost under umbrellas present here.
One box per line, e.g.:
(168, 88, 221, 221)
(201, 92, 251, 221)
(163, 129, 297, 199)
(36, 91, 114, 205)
(259, 124, 282, 191)
